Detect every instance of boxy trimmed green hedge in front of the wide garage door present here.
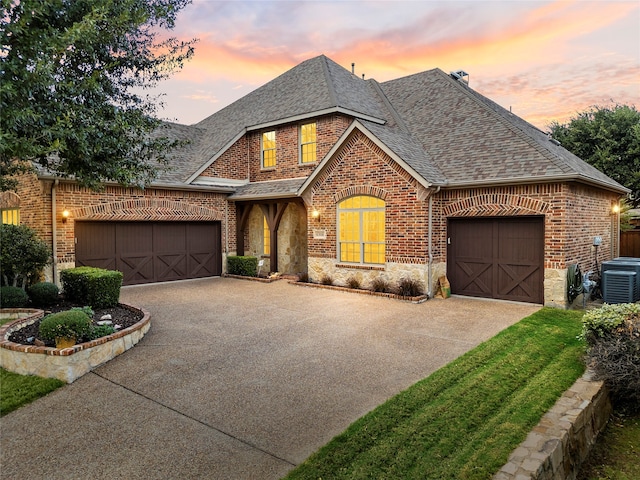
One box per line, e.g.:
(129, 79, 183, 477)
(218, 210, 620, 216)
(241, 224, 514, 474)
(60, 267, 122, 308)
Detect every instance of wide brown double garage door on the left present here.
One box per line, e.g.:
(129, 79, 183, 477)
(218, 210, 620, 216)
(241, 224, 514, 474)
(75, 222, 222, 285)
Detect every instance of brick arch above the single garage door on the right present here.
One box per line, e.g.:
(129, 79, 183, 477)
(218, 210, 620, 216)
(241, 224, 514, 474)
(444, 194, 549, 217)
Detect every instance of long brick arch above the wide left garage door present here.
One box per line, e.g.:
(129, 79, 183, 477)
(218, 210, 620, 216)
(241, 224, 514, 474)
(71, 198, 223, 221)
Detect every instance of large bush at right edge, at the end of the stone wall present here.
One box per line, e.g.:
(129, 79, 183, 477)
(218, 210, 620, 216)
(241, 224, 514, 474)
(582, 304, 640, 409)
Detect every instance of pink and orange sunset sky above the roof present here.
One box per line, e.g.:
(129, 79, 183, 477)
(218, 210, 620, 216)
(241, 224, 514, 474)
(151, 0, 640, 130)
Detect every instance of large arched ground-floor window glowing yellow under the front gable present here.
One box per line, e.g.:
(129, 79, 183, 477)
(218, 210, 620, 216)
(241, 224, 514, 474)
(338, 196, 385, 264)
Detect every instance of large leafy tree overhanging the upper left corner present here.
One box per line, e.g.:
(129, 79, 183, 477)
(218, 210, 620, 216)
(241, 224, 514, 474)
(0, 0, 194, 191)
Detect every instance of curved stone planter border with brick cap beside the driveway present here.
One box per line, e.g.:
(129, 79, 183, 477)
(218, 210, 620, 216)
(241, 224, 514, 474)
(0, 303, 151, 383)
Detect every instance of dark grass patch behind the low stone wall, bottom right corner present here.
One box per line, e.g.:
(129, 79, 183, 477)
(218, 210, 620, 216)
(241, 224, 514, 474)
(577, 411, 640, 480)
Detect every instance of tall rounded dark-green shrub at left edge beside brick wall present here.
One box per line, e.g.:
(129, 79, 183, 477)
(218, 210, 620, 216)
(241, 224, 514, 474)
(0, 224, 51, 289)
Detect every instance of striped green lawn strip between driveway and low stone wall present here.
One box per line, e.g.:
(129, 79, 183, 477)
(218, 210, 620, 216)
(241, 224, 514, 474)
(287, 308, 584, 479)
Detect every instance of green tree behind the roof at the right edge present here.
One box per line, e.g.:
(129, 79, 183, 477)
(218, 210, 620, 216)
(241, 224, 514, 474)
(549, 105, 640, 207)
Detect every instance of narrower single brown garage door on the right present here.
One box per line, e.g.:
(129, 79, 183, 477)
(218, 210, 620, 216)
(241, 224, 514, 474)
(447, 217, 544, 303)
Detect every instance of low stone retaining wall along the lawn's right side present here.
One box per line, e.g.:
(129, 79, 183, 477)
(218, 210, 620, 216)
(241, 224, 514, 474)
(493, 372, 612, 480)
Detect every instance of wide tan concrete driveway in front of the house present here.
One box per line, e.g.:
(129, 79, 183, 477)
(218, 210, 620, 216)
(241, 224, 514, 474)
(0, 278, 540, 479)
